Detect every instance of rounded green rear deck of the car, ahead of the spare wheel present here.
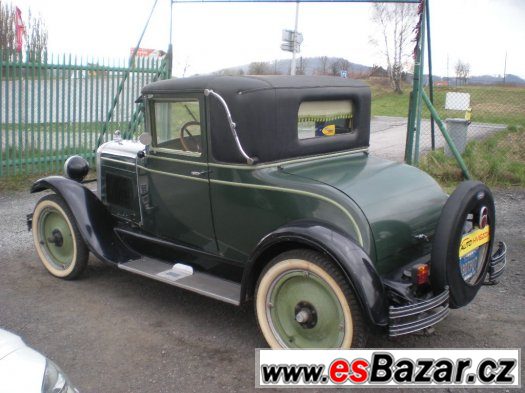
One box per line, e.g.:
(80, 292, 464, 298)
(283, 153, 447, 273)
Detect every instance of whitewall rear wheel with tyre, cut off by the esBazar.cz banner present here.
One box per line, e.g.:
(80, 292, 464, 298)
(255, 250, 366, 349)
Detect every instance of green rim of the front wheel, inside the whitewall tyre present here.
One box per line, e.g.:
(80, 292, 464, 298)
(39, 208, 75, 270)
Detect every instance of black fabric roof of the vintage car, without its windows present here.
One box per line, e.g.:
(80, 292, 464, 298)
(142, 75, 370, 163)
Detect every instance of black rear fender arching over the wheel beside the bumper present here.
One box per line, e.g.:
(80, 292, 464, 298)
(242, 221, 388, 326)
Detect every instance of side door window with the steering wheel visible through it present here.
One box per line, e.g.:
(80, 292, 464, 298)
(154, 99, 202, 153)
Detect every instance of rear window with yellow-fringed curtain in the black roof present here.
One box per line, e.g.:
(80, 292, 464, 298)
(297, 100, 353, 139)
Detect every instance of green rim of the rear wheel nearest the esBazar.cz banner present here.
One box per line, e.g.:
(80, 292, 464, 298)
(267, 270, 345, 348)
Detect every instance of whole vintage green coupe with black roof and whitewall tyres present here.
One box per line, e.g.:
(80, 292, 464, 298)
(28, 76, 506, 348)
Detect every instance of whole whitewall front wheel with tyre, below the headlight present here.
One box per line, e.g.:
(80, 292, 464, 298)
(32, 194, 89, 279)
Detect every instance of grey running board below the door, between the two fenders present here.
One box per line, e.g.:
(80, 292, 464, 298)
(118, 257, 241, 306)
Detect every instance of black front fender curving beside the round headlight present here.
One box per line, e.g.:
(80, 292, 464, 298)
(31, 176, 134, 263)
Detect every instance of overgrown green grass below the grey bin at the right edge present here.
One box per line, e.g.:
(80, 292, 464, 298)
(420, 126, 525, 189)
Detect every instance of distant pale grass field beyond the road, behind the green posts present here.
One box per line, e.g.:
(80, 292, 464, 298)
(368, 81, 525, 126)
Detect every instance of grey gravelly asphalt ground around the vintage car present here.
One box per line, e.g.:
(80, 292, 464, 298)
(0, 190, 525, 393)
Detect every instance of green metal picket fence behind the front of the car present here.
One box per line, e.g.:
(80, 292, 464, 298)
(0, 51, 166, 176)
